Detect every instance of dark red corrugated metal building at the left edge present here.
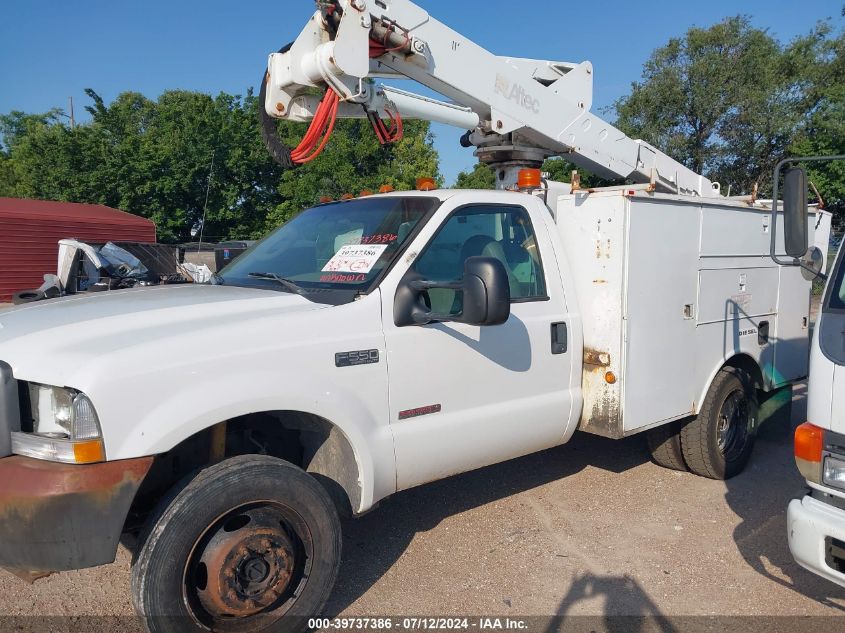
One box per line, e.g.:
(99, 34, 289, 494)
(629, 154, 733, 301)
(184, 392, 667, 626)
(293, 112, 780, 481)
(0, 198, 156, 302)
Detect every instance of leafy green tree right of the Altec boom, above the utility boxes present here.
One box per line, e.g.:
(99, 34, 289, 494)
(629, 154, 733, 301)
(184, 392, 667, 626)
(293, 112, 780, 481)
(615, 16, 831, 193)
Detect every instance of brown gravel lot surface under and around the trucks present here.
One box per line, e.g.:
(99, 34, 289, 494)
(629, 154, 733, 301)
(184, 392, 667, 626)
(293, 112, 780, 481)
(0, 392, 845, 630)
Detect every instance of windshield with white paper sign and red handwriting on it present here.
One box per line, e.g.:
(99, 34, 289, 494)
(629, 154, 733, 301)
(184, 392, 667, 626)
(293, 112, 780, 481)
(220, 196, 440, 293)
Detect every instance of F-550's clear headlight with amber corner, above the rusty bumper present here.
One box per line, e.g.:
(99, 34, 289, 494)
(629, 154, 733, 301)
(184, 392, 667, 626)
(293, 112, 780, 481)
(12, 383, 105, 464)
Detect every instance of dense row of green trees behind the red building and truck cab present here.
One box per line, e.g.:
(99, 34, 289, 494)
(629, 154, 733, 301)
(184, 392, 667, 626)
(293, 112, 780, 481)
(0, 90, 439, 241)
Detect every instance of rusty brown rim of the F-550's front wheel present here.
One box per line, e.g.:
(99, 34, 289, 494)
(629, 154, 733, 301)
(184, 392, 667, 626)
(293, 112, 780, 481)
(183, 501, 313, 631)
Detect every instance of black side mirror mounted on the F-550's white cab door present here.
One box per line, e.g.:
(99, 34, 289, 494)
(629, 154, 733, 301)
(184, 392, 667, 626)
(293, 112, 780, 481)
(393, 257, 511, 327)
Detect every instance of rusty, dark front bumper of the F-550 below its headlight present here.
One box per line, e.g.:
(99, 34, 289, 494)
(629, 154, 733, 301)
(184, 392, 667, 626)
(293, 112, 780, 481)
(0, 455, 153, 580)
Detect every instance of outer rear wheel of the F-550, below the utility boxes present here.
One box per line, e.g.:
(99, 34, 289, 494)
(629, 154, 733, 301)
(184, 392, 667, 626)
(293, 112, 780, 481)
(681, 367, 759, 479)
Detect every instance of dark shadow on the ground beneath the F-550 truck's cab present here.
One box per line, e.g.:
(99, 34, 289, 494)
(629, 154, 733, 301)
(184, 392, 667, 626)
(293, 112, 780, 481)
(326, 433, 649, 616)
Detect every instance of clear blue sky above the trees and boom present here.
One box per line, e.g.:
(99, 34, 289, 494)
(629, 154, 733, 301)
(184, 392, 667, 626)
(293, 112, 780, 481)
(0, 0, 845, 183)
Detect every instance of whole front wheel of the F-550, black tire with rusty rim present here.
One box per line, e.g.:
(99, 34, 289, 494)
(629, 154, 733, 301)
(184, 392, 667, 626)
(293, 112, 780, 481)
(132, 455, 341, 633)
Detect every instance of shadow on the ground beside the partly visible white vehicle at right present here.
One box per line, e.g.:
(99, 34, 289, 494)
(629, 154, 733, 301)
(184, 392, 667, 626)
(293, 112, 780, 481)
(725, 385, 845, 612)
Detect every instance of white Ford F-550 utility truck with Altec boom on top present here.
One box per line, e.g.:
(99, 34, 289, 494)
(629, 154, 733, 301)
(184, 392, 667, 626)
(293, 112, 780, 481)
(0, 0, 830, 631)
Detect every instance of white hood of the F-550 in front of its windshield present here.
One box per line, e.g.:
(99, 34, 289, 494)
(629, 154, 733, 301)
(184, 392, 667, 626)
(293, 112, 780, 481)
(0, 285, 329, 387)
